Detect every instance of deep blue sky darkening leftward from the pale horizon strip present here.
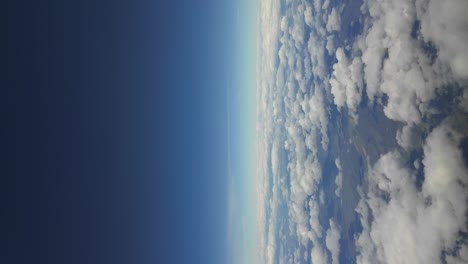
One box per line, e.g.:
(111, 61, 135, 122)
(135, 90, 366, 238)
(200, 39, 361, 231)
(0, 0, 236, 264)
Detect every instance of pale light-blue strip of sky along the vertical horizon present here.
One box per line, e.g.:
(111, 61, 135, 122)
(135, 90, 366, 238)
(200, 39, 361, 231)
(227, 1, 257, 263)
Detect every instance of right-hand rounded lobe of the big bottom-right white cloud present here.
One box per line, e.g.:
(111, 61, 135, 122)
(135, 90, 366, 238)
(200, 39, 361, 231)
(422, 126, 468, 231)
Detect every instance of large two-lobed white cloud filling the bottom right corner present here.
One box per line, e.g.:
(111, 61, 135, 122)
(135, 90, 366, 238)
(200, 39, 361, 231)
(356, 125, 468, 263)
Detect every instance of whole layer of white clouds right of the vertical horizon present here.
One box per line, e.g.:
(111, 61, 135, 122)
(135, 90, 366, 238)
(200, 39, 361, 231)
(256, 0, 468, 263)
